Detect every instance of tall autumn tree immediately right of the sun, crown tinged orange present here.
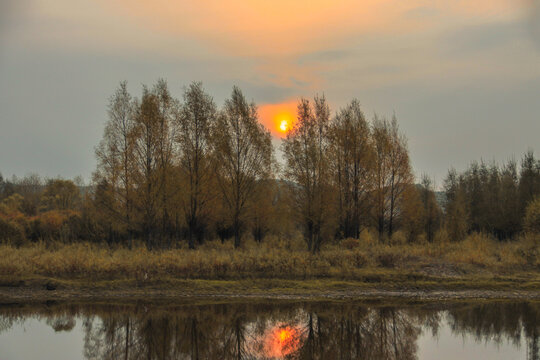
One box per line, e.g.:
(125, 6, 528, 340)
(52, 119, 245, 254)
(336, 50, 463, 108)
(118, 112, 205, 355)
(283, 96, 330, 252)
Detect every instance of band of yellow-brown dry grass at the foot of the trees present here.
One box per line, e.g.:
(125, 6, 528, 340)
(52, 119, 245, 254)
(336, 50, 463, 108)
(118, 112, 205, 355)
(0, 233, 540, 280)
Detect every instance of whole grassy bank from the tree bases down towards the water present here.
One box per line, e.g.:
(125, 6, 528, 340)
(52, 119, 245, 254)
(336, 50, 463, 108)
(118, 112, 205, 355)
(0, 234, 540, 293)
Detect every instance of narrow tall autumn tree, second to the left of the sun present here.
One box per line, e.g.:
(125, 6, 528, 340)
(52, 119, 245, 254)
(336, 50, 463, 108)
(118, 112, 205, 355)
(176, 83, 217, 249)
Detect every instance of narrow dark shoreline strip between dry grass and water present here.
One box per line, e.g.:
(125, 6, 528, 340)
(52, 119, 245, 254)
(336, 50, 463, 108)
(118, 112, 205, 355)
(0, 278, 540, 305)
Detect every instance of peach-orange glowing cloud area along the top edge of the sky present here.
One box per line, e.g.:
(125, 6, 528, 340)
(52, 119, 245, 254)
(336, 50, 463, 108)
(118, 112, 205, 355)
(96, 0, 515, 56)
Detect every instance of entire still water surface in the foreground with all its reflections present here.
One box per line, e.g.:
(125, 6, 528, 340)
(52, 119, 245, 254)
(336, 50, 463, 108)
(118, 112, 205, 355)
(0, 301, 540, 360)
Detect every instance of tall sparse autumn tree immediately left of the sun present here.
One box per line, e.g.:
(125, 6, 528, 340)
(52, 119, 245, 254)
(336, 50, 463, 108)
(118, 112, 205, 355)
(213, 87, 273, 248)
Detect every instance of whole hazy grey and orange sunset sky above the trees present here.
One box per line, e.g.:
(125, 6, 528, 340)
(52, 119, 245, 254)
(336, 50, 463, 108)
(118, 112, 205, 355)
(0, 0, 540, 185)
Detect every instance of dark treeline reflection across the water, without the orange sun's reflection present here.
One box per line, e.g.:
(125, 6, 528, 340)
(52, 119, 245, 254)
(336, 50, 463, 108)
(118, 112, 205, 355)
(0, 302, 540, 360)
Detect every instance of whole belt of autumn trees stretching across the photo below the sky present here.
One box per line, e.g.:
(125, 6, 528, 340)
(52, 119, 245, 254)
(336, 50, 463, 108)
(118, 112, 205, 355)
(0, 80, 540, 252)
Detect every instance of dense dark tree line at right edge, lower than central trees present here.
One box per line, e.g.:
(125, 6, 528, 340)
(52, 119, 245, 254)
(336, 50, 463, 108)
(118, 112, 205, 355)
(444, 151, 540, 240)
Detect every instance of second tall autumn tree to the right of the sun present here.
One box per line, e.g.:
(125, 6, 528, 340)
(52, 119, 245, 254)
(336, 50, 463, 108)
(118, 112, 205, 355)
(328, 100, 374, 238)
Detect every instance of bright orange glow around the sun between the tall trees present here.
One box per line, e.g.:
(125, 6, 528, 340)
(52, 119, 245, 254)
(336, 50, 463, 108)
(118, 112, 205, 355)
(259, 101, 297, 137)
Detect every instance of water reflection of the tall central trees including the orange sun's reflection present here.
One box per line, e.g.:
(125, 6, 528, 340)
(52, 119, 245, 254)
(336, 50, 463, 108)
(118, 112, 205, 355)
(79, 306, 421, 360)
